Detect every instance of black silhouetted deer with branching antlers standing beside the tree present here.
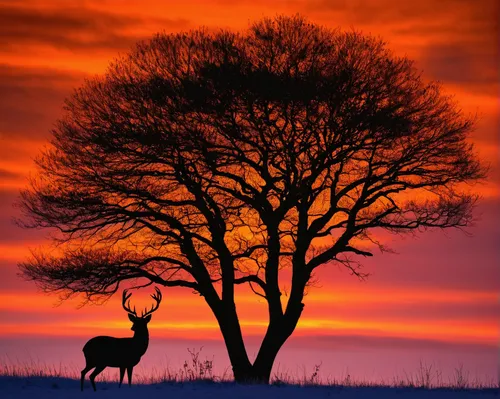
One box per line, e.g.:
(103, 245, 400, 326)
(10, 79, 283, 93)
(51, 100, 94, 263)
(81, 287, 162, 391)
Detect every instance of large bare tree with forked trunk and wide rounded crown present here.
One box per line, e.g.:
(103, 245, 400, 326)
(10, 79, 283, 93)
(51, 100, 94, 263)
(20, 16, 486, 382)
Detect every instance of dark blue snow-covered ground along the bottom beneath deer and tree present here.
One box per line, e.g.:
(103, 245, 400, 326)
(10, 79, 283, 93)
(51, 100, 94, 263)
(0, 377, 500, 399)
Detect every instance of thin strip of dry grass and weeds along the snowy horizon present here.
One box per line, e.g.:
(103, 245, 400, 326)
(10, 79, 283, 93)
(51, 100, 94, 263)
(0, 348, 500, 389)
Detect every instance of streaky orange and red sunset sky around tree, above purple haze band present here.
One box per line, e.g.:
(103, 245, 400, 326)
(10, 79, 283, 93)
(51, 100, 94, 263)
(0, 0, 500, 382)
